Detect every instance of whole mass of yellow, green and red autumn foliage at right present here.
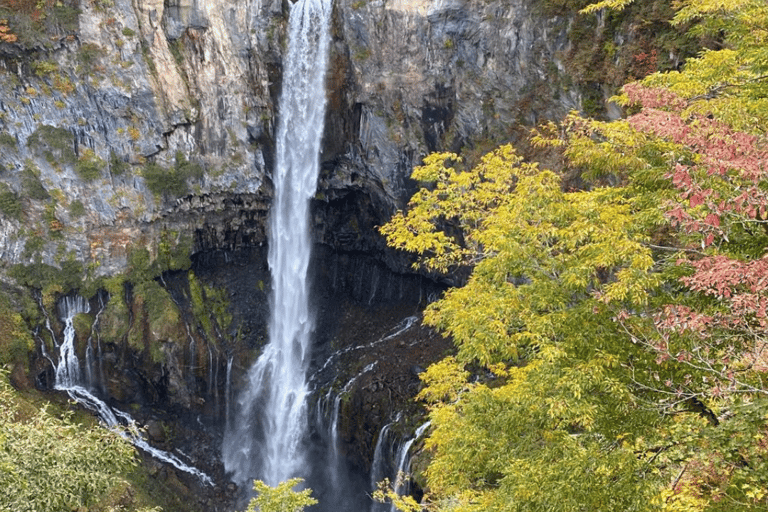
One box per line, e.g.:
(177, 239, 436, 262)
(382, 0, 768, 512)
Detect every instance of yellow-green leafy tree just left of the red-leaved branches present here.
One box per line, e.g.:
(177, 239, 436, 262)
(382, 140, 660, 511)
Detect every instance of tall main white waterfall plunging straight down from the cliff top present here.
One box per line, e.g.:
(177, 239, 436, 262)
(223, 0, 331, 486)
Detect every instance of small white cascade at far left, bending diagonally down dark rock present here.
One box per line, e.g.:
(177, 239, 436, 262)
(53, 296, 213, 485)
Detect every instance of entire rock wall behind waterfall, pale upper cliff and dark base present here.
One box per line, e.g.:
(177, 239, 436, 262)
(0, 0, 616, 511)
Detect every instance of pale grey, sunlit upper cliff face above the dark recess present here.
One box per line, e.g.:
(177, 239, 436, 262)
(0, 0, 578, 275)
